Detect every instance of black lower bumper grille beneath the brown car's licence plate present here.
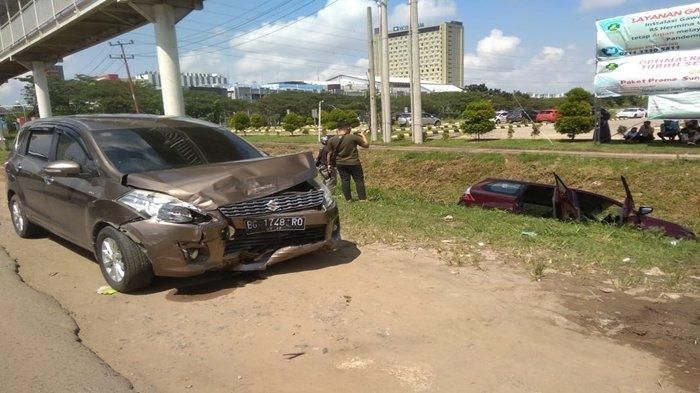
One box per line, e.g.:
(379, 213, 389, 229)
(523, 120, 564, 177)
(225, 226, 326, 255)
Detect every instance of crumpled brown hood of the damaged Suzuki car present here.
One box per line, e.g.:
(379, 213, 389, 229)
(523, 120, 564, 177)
(125, 152, 317, 210)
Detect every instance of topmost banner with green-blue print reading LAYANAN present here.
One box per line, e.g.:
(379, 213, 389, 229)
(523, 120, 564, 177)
(596, 3, 700, 60)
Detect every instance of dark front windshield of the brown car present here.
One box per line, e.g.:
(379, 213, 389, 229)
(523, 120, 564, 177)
(93, 126, 263, 173)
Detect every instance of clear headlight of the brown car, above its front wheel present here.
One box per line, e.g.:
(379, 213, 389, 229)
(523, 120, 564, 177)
(118, 190, 204, 224)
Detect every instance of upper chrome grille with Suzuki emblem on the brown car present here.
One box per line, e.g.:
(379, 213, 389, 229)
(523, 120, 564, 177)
(219, 190, 324, 218)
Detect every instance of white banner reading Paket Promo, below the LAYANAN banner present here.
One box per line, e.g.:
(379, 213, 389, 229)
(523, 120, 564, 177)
(594, 50, 700, 97)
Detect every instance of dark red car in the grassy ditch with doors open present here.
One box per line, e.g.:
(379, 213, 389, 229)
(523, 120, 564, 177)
(459, 173, 695, 239)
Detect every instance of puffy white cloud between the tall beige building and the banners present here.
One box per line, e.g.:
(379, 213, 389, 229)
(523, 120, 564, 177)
(464, 29, 593, 93)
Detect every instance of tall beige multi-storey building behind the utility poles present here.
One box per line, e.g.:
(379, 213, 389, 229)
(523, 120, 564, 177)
(374, 21, 464, 87)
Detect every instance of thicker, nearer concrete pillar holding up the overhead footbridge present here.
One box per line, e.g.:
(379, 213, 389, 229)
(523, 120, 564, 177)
(153, 4, 185, 116)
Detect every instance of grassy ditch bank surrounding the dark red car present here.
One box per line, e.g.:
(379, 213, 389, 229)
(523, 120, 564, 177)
(264, 145, 700, 290)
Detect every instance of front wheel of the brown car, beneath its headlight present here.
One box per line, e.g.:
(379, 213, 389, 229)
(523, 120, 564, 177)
(95, 227, 153, 292)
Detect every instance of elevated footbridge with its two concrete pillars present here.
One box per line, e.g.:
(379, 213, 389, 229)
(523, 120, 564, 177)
(0, 0, 203, 117)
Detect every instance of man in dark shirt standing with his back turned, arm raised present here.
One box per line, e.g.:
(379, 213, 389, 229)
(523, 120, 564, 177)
(327, 124, 369, 201)
